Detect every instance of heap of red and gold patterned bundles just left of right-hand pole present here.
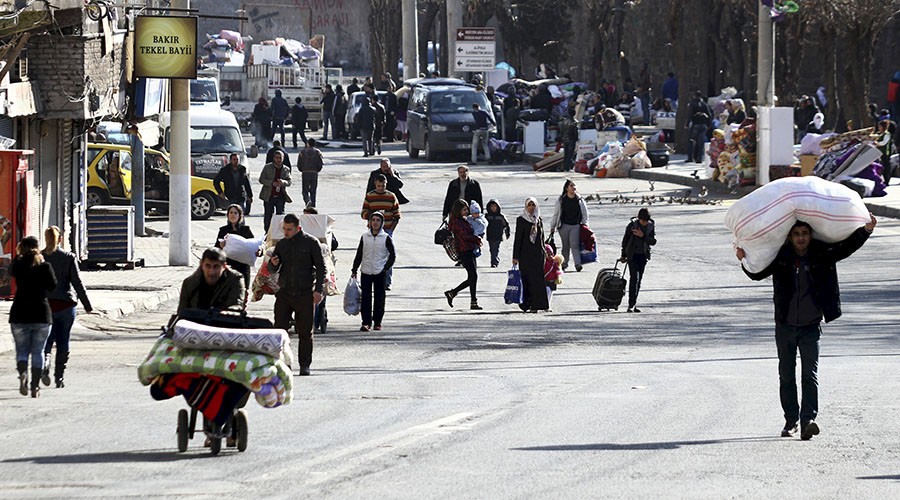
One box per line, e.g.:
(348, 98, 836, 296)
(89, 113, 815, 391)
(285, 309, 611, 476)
(709, 118, 756, 187)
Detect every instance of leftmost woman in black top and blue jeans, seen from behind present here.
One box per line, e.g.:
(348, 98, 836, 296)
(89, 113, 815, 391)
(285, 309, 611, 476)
(9, 236, 56, 398)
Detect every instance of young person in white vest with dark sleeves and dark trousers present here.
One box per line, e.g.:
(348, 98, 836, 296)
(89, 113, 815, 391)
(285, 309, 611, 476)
(351, 212, 396, 332)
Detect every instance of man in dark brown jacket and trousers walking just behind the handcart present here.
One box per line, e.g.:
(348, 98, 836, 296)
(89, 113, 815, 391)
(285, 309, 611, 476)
(267, 214, 325, 375)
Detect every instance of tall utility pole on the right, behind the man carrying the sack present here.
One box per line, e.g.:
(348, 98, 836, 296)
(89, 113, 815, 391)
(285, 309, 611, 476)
(756, 2, 775, 186)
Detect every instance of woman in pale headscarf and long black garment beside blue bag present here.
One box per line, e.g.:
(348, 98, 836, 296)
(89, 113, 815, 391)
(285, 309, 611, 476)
(513, 198, 550, 312)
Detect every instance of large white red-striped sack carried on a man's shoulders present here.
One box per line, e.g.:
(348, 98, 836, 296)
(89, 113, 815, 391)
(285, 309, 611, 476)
(725, 176, 870, 273)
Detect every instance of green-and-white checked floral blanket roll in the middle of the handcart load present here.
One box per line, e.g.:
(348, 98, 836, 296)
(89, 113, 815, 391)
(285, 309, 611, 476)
(138, 337, 293, 408)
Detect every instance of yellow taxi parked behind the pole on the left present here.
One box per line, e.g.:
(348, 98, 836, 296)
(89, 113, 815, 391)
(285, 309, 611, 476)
(87, 144, 228, 220)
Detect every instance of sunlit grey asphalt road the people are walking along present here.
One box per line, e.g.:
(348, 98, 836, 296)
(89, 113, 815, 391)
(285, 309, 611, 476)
(0, 139, 900, 499)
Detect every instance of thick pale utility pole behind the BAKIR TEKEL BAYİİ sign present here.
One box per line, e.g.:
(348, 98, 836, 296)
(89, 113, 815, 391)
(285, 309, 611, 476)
(169, 0, 191, 266)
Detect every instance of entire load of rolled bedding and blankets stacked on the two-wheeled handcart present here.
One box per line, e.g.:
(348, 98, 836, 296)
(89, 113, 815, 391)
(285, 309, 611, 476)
(138, 319, 293, 423)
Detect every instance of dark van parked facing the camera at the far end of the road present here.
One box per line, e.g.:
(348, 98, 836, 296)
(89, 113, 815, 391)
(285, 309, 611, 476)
(406, 84, 491, 161)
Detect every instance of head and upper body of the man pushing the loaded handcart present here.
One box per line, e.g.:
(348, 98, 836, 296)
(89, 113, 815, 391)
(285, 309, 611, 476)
(177, 248, 244, 312)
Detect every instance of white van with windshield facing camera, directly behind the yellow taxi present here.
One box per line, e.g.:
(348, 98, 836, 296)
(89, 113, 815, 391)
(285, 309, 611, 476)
(159, 107, 246, 179)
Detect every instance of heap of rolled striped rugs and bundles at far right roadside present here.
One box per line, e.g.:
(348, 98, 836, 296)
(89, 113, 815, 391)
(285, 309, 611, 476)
(801, 128, 890, 197)
